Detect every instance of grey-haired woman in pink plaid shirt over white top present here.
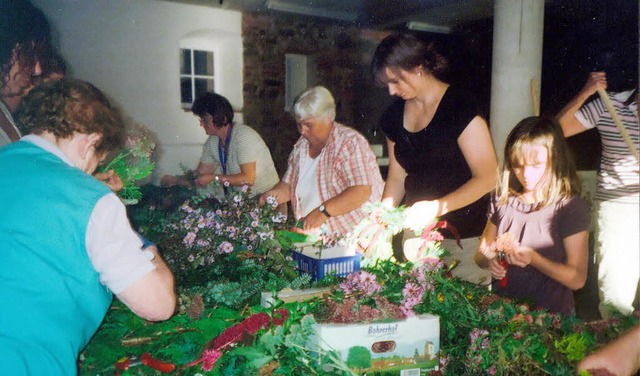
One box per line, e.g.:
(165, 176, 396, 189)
(260, 86, 384, 237)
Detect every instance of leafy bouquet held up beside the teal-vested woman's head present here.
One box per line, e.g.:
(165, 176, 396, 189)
(101, 124, 156, 205)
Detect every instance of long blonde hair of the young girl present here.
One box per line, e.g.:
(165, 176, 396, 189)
(497, 116, 581, 208)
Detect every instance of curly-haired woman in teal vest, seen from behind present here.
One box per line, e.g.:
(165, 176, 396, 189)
(0, 80, 176, 375)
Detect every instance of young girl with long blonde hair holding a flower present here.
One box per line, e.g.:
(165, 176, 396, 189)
(475, 117, 590, 314)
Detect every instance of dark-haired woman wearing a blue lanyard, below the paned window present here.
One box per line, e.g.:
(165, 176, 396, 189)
(160, 93, 279, 196)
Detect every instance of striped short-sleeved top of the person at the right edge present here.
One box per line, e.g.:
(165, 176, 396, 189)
(575, 90, 640, 204)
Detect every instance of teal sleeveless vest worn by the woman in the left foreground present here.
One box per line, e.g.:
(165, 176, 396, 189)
(0, 141, 112, 375)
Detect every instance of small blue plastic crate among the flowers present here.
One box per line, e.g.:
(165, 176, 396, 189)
(293, 251, 362, 281)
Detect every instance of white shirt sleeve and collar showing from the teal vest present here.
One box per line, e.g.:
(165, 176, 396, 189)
(22, 135, 156, 294)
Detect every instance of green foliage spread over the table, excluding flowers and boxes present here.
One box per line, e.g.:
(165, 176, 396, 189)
(79, 191, 639, 376)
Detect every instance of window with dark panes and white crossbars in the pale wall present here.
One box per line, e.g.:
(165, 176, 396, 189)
(180, 48, 214, 109)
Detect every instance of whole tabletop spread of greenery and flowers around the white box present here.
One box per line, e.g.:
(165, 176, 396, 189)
(79, 186, 639, 375)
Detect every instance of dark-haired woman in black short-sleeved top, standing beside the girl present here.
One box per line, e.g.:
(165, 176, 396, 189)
(371, 33, 497, 283)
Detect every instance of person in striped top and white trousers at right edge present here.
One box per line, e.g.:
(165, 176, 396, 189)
(558, 72, 640, 318)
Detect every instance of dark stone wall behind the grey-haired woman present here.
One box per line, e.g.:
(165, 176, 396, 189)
(242, 14, 390, 175)
